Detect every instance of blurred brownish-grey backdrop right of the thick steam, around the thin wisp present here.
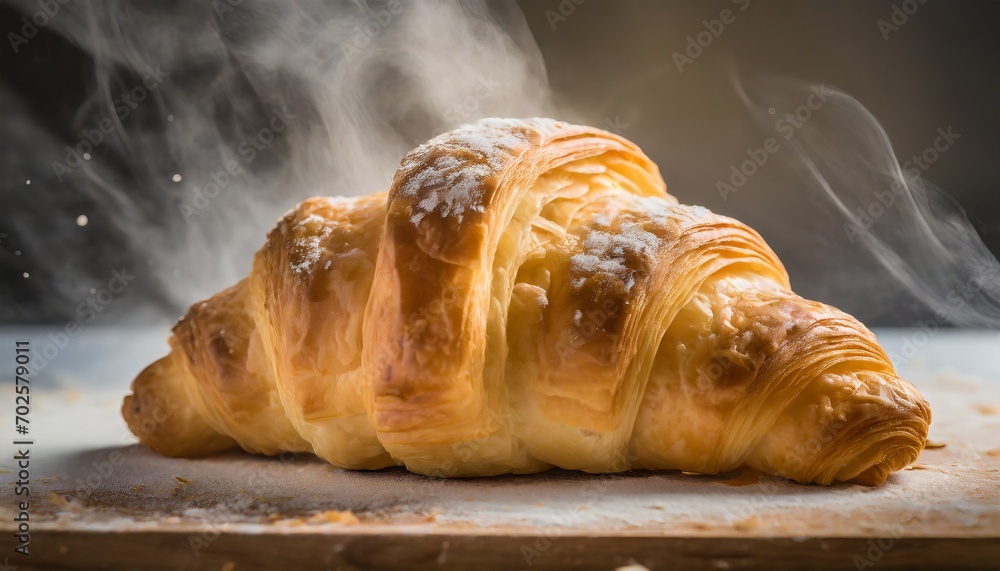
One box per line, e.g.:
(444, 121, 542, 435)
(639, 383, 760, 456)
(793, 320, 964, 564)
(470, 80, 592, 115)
(520, 0, 1000, 326)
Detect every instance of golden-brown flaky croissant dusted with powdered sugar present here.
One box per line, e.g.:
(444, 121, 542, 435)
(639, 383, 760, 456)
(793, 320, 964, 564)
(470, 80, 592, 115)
(122, 119, 931, 485)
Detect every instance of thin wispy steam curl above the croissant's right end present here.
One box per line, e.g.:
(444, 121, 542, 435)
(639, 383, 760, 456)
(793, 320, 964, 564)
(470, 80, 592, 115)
(737, 80, 1000, 329)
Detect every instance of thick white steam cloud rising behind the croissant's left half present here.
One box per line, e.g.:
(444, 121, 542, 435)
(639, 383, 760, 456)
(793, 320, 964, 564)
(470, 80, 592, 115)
(7, 0, 552, 317)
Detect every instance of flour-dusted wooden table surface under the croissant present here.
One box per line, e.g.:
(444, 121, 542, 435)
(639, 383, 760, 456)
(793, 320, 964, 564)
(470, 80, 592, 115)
(0, 330, 1000, 571)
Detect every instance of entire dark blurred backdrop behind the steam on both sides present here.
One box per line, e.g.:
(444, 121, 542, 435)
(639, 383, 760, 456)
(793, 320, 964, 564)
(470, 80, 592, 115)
(0, 0, 1000, 326)
